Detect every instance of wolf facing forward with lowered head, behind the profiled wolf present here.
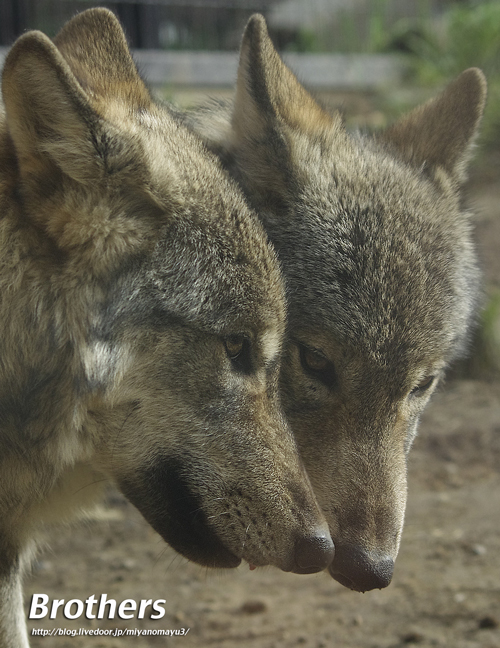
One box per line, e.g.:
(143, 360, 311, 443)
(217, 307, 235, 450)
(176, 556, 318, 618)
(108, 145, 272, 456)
(186, 15, 486, 591)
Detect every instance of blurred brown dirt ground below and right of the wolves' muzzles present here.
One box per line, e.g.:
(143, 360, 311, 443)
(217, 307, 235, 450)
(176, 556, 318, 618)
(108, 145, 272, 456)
(25, 178, 500, 648)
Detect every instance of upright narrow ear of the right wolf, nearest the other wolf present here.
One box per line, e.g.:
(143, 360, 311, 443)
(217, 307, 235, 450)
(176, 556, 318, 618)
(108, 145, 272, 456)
(233, 14, 333, 135)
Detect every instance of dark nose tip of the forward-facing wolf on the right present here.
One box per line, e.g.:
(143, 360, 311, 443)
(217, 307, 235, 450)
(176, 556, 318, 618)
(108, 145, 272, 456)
(329, 544, 394, 592)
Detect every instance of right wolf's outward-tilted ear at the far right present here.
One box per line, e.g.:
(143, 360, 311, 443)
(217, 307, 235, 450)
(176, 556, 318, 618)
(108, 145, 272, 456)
(380, 68, 486, 183)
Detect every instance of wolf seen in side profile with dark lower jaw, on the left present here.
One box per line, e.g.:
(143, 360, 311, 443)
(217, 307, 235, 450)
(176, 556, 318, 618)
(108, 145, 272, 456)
(0, 10, 333, 648)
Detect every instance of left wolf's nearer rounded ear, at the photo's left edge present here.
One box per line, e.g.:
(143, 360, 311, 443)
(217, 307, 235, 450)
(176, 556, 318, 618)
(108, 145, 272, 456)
(2, 31, 103, 182)
